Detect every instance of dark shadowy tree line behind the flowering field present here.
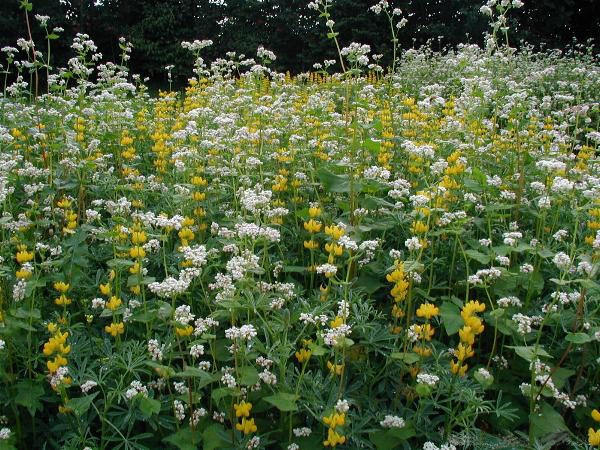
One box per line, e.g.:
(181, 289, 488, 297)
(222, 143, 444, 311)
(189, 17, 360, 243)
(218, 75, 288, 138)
(0, 0, 600, 87)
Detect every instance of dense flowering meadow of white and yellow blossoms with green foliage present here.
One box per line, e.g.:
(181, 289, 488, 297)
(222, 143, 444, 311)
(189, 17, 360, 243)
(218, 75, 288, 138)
(0, 4, 600, 450)
